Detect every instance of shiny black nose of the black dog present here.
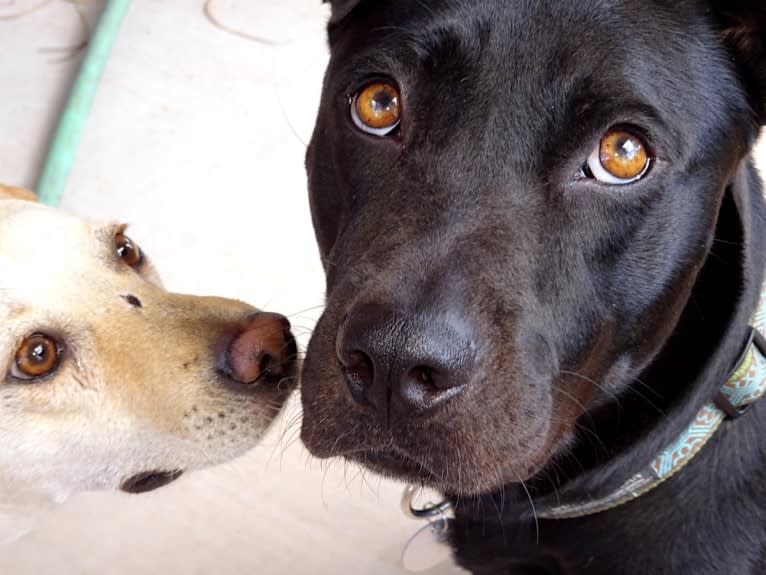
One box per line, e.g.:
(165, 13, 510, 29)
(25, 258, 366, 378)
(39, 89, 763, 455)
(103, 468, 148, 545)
(336, 304, 476, 418)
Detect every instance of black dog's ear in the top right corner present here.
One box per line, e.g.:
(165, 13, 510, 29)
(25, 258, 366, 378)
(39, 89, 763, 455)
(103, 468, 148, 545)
(710, 0, 766, 125)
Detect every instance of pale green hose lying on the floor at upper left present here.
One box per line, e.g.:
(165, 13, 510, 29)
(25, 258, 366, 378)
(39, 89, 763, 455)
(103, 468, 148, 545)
(36, 0, 130, 206)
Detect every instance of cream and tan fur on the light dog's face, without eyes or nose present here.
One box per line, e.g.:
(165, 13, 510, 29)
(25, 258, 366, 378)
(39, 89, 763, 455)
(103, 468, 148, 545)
(0, 187, 290, 540)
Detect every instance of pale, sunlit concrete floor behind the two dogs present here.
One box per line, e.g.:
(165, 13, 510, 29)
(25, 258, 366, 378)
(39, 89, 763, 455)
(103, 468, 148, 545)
(0, 0, 766, 575)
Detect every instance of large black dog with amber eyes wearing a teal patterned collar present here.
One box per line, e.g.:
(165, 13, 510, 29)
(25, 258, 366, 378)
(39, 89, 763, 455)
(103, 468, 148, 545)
(302, 0, 766, 575)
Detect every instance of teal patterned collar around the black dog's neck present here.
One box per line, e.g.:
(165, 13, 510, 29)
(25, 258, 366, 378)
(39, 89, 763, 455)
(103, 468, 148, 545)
(537, 285, 766, 519)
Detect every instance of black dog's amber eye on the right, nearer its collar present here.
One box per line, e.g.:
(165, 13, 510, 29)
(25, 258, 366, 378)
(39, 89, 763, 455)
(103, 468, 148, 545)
(583, 129, 652, 185)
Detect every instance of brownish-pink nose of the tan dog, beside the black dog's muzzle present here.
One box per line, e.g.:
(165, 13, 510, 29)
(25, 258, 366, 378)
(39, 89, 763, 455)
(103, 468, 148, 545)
(224, 312, 294, 383)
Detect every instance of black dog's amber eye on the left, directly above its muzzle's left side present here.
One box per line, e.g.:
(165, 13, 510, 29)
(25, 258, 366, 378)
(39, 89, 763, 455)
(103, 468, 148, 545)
(351, 82, 401, 136)
